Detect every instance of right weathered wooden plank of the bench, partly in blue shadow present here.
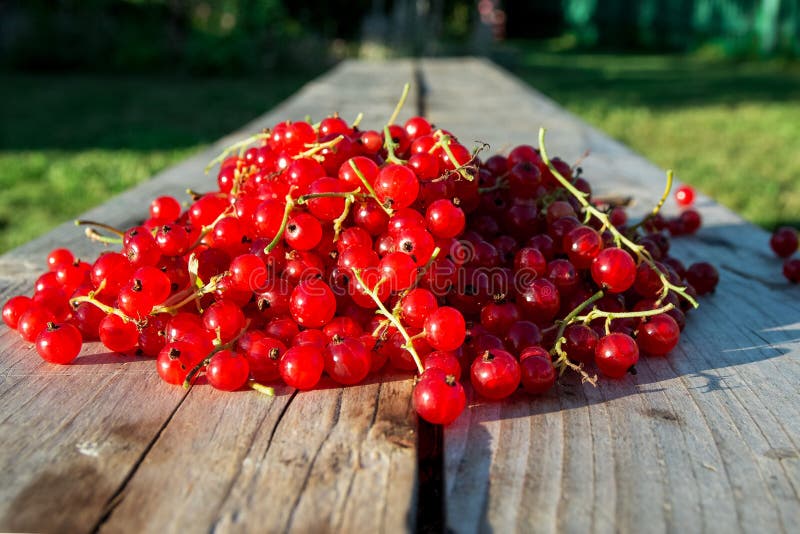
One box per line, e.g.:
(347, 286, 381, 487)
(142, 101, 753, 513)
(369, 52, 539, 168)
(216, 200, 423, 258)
(422, 59, 800, 533)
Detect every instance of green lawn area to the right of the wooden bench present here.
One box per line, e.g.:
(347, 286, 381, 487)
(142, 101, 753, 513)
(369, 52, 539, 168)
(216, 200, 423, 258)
(500, 45, 800, 229)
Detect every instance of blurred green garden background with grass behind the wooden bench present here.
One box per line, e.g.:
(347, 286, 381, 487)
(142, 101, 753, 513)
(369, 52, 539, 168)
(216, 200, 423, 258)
(0, 0, 800, 251)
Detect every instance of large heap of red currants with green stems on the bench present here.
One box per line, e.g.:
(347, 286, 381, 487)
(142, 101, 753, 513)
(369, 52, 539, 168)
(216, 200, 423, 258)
(2, 96, 718, 430)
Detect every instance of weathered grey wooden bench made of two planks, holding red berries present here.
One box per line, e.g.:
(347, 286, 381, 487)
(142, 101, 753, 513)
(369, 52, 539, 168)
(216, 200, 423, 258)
(0, 59, 800, 533)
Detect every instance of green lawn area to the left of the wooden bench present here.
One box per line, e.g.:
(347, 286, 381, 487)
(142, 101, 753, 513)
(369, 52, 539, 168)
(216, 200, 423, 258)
(0, 75, 308, 252)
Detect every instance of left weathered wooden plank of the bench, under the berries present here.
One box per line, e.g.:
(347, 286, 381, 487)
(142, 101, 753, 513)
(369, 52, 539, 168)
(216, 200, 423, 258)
(0, 61, 416, 532)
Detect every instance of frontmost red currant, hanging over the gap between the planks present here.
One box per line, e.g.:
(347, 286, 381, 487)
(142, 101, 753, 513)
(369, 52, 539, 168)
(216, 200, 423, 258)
(412, 369, 467, 425)
